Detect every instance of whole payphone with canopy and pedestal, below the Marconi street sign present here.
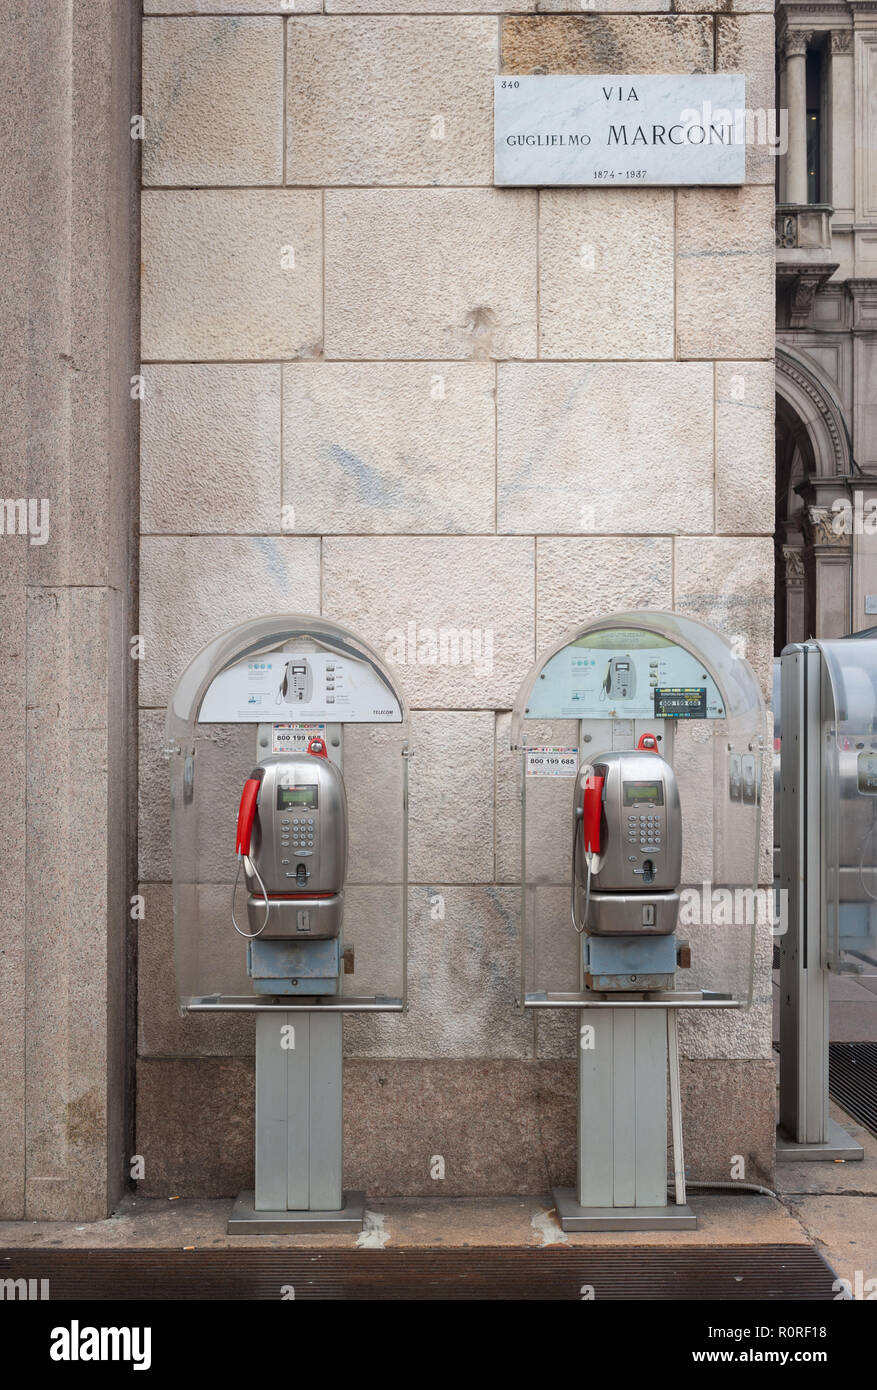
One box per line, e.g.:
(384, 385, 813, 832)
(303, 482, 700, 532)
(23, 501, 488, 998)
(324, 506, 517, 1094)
(510, 612, 766, 1232)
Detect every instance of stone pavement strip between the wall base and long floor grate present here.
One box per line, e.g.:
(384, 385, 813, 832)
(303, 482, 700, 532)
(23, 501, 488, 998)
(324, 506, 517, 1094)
(0, 1106, 877, 1289)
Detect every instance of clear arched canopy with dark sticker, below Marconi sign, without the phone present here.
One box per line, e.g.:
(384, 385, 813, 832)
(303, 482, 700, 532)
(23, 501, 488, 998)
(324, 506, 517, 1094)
(510, 610, 773, 1008)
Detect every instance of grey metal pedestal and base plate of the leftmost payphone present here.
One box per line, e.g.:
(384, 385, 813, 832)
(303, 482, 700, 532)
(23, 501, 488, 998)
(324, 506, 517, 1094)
(228, 1009, 366, 1236)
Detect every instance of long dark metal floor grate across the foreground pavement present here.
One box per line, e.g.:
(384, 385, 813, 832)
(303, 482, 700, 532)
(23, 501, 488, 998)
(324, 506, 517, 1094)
(0, 1245, 834, 1302)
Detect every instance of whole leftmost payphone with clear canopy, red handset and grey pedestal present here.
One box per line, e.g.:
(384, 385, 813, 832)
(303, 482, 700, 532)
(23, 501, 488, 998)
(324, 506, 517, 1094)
(167, 613, 410, 1236)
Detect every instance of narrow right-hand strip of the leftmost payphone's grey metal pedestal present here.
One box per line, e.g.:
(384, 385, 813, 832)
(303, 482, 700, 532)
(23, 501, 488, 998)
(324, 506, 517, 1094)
(307, 1011, 343, 1211)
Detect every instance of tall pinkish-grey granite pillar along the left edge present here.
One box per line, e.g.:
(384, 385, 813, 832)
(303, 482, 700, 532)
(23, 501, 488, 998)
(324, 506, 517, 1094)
(0, 0, 140, 1220)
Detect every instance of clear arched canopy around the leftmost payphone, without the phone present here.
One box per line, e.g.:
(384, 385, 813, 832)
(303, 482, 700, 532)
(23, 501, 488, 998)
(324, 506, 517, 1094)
(165, 613, 410, 1013)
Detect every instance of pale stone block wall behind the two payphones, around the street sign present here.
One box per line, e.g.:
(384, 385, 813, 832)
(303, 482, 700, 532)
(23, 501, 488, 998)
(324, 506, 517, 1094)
(138, 0, 774, 1194)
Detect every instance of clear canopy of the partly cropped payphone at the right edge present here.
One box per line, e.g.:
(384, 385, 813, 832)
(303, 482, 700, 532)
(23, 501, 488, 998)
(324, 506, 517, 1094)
(813, 635, 877, 977)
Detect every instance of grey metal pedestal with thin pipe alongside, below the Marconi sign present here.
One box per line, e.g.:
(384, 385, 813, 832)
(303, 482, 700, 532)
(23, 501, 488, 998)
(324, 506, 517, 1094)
(553, 1005, 698, 1232)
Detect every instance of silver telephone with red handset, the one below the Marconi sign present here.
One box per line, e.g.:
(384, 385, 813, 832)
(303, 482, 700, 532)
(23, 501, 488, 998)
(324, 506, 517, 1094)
(570, 734, 687, 991)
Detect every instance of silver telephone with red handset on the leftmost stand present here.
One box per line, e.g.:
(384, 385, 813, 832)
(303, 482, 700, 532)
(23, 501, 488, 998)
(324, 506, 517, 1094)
(232, 738, 347, 995)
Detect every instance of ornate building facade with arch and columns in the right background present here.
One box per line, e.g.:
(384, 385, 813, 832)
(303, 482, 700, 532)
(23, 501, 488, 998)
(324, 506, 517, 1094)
(777, 0, 877, 651)
